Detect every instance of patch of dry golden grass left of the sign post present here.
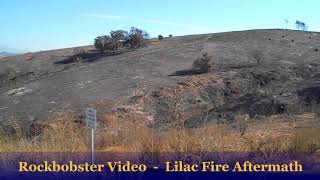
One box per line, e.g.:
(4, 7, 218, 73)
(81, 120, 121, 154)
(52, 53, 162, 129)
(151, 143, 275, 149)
(0, 114, 88, 152)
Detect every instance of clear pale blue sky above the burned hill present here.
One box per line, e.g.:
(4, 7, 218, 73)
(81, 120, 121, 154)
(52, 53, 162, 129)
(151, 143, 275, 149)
(0, 0, 320, 52)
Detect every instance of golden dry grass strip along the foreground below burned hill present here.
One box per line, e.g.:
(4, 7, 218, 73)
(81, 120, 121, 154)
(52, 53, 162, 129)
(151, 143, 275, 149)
(0, 111, 320, 156)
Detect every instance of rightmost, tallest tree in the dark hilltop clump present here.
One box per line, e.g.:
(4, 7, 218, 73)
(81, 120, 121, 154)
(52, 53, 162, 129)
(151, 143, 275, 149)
(124, 27, 149, 49)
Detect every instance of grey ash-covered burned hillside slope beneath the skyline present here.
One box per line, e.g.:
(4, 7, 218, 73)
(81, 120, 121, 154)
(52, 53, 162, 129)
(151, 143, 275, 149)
(0, 30, 320, 128)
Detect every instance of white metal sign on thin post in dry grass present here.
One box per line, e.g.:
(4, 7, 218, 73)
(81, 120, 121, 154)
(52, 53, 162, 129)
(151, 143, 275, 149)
(86, 108, 97, 164)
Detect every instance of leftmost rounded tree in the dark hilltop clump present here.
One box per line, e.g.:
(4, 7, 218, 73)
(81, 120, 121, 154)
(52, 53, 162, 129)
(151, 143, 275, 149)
(94, 35, 116, 54)
